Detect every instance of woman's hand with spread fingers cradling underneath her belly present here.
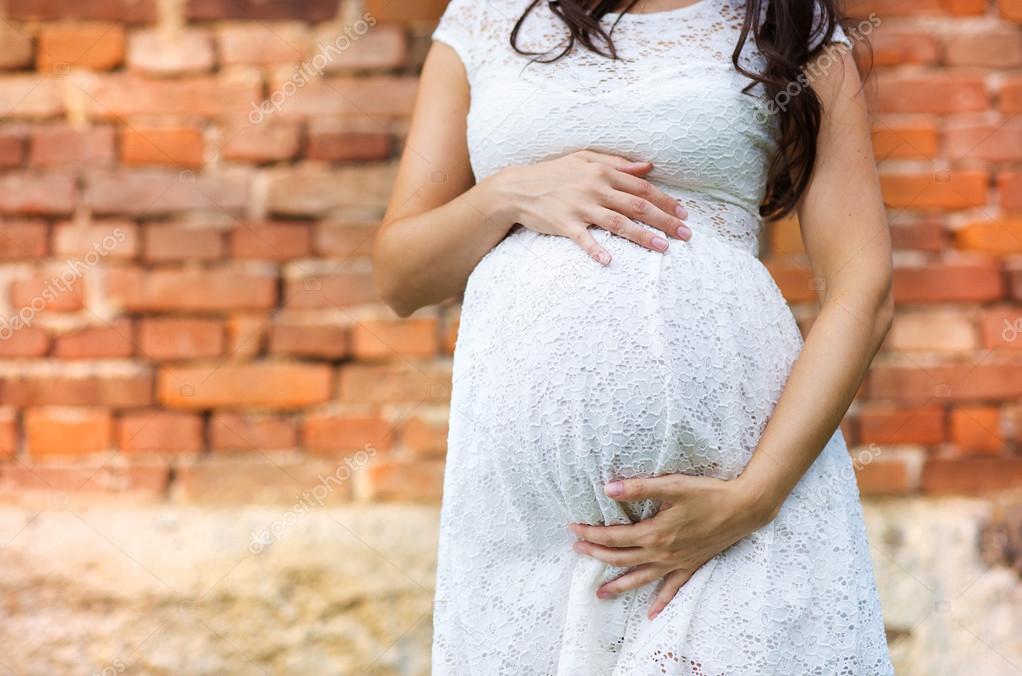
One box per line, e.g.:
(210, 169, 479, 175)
(569, 475, 780, 620)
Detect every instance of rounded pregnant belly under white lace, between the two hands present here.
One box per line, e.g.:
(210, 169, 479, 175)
(450, 223, 801, 523)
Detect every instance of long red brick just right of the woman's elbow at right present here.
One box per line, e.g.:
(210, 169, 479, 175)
(894, 260, 1005, 303)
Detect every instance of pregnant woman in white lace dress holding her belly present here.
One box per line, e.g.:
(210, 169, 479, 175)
(375, 0, 893, 676)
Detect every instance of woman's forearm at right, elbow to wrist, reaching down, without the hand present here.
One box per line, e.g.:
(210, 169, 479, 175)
(740, 284, 892, 522)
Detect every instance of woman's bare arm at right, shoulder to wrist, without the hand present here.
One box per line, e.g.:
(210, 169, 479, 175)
(740, 47, 893, 517)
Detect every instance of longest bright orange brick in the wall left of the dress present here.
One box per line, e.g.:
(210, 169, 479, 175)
(156, 362, 332, 409)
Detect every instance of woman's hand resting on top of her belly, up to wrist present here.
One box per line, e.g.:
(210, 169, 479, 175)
(485, 150, 692, 265)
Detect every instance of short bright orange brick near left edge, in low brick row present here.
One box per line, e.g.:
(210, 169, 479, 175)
(25, 408, 112, 456)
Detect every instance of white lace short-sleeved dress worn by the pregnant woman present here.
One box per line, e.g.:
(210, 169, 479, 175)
(433, 0, 893, 676)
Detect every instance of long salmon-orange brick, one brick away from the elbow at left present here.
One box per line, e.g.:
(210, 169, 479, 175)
(105, 269, 277, 312)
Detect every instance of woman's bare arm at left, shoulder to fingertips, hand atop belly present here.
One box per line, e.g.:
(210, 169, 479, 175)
(373, 44, 692, 316)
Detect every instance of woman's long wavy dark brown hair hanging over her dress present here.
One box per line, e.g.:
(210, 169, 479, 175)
(511, 0, 862, 218)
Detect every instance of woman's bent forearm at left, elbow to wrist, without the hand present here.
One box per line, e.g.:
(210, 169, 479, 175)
(373, 181, 514, 316)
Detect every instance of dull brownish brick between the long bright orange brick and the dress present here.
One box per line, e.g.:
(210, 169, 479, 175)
(339, 362, 451, 404)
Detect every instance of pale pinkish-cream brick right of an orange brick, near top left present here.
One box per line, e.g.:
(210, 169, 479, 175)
(128, 29, 216, 75)
